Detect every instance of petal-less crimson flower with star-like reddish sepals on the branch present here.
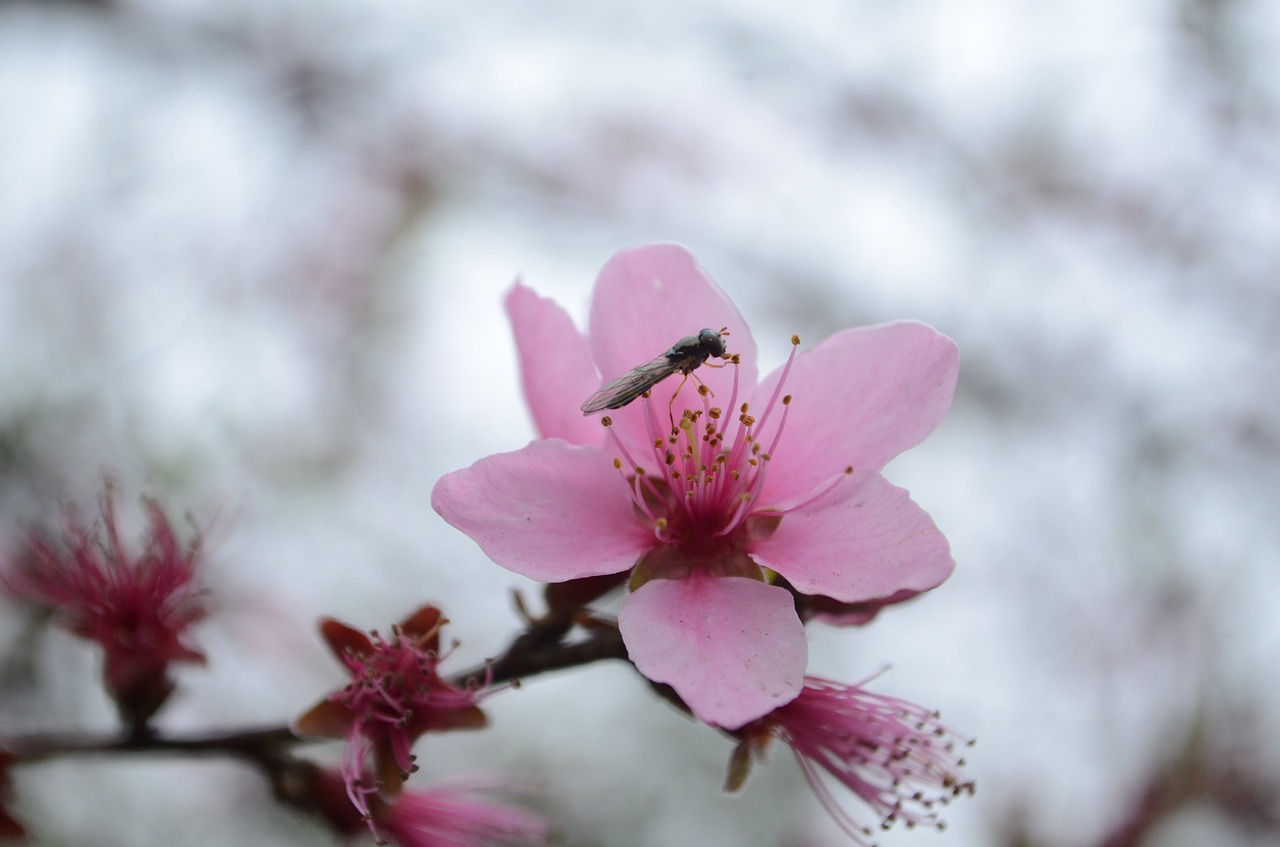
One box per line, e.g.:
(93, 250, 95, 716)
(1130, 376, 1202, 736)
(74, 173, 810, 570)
(294, 606, 486, 818)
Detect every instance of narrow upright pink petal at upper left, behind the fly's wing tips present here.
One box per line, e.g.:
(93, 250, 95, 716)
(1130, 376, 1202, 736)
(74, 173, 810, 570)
(507, 281, 604, 444)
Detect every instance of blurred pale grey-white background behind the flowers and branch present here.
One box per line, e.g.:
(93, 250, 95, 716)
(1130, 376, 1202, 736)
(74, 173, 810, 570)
(0, 0, 1280, 847)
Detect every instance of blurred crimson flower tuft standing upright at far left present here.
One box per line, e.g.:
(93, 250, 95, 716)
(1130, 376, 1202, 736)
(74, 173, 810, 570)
(4, 487, 206, 727)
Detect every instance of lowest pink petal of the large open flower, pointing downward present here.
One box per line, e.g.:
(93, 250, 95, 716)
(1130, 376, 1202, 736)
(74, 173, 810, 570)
(618, 574, 809, 729)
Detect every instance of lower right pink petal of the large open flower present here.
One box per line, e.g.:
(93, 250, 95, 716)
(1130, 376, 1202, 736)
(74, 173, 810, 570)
(750, 471, 955, 603)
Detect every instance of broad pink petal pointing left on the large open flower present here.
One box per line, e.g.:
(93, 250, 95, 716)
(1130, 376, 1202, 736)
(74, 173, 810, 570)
(431, 439, 654, 582)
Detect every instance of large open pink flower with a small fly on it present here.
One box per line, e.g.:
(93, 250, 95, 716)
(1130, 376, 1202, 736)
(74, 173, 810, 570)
(431, 244, 959, 728)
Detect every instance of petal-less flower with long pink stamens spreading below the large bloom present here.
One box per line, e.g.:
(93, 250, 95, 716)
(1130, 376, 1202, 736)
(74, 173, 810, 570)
(724, 677, 974, 844)
